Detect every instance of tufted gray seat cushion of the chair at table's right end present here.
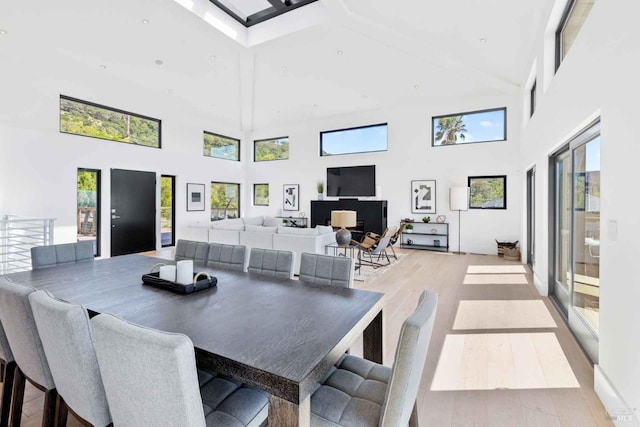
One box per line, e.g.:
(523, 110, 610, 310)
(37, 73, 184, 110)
(311, 355, 391, 427)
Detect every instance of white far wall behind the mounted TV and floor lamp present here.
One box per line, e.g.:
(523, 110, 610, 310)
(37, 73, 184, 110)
(245, 97, 522, 254)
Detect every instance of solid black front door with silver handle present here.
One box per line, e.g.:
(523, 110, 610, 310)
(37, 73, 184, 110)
(111, 169, 156, 256)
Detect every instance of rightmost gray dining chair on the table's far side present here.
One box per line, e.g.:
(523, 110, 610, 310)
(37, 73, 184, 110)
(299, 252, 354, 288)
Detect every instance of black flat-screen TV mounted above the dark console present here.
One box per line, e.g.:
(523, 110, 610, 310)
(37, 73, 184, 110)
(327, 165, 376, 197)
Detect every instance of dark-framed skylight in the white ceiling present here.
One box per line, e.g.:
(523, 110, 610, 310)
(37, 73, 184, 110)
(209, 0, 317, 28)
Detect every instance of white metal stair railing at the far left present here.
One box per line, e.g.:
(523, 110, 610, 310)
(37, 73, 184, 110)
(0, 215, 55, 274)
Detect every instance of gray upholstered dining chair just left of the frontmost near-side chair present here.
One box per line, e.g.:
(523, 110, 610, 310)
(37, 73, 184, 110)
(29, 291, 111, 427)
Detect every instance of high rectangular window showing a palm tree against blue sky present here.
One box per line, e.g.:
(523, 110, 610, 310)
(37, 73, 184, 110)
(431, 108, 507, 147)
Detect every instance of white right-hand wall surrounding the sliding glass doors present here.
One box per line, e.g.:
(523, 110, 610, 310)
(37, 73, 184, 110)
(522, 0, 640, 420)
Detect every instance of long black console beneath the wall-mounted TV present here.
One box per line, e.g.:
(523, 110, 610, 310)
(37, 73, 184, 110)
(311, 199, 387, 240)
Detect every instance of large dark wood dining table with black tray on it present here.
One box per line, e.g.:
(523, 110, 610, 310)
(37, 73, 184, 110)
(4, 255, 383, 426)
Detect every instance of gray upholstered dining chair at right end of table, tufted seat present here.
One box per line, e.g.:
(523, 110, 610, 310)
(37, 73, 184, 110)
(311, 291, 438, 427)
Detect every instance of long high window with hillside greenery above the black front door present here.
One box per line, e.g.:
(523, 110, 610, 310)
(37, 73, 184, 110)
(60, 95, 161, 148)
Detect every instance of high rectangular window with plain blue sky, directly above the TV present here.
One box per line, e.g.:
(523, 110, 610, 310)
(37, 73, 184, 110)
(320, 123, 387, 156)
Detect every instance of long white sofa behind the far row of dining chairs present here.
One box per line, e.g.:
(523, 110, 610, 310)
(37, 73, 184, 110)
(181, 217, 336, 274)
